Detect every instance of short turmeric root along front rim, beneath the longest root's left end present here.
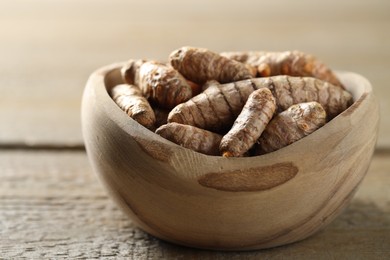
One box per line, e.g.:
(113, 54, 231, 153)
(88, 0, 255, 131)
(156, 123, 222, 155)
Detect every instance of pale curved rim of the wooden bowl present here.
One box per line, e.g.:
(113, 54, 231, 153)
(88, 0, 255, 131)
(87, 61, 373, 162)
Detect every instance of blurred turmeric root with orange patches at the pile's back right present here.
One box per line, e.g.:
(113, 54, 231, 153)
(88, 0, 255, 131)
(221, 51, 342, 87)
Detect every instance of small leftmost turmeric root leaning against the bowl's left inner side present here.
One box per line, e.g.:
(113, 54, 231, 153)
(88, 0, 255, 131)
(110, 84, 156, 129)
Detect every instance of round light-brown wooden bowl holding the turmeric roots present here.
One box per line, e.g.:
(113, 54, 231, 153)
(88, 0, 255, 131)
(82, 63, 379, 250)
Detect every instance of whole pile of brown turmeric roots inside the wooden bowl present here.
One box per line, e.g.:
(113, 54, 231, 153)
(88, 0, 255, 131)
(110, 47, 352, 157)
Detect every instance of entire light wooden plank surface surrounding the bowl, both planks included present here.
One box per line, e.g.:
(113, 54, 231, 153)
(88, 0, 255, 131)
(0, 0, 390, 259)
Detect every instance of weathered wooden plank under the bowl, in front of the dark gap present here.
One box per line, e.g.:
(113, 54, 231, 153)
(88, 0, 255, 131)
(0, 151, 390, 259)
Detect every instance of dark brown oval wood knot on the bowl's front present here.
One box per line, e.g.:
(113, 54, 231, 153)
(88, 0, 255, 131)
(198, 162, 298, 191)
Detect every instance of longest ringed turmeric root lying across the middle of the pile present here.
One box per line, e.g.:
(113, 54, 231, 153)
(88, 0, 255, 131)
(168, 76, 352, 132)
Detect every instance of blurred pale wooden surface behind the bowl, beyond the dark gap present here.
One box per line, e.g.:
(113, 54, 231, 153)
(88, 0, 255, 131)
(0, 0, 390, 149)
